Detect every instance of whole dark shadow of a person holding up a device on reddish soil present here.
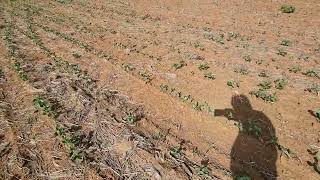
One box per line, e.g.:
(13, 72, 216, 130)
(215, 95, 278, 179)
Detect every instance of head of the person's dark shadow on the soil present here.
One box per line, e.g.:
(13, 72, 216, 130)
(231, 94, 253, 112)
